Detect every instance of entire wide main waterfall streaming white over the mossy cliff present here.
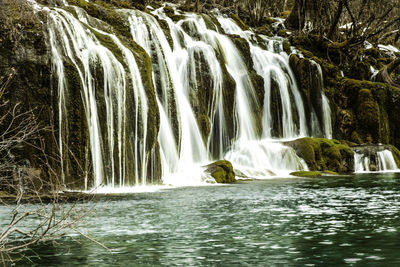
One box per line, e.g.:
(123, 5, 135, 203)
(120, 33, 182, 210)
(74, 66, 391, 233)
(32, 0, 338, 186)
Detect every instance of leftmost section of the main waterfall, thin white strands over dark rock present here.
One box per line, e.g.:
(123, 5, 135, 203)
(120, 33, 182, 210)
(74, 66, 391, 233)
(49, 7, 148, 187)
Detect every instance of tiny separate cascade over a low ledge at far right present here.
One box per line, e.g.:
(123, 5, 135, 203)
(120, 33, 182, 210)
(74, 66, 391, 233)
(353, 145, 399, 173)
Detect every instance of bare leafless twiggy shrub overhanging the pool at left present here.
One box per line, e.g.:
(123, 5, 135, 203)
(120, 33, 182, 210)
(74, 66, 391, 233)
(0, 69, 99, 266)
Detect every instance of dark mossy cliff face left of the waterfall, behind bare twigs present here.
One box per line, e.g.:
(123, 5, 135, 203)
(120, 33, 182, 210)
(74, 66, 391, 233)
(0, 0, 60, 186)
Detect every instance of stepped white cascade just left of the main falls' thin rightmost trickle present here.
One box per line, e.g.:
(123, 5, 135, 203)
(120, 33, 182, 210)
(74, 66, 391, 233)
(218, 16, 308, 139)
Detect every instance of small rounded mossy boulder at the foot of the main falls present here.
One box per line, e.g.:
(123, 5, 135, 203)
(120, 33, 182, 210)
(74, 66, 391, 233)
(204, 160, 236, 184)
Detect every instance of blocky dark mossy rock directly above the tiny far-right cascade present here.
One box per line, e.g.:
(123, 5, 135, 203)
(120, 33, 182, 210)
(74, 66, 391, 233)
(334, 78, 400, 146)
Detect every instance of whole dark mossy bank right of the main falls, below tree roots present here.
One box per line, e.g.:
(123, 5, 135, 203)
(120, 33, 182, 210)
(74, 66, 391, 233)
(290, 35, 400, 151)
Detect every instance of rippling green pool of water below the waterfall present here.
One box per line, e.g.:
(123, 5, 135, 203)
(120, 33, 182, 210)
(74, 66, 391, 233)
(6, 174, 400, 266)
